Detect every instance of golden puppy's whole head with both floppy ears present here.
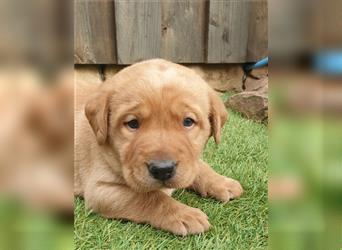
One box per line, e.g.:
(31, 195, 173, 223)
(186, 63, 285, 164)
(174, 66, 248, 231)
(85, 60, 227, 192)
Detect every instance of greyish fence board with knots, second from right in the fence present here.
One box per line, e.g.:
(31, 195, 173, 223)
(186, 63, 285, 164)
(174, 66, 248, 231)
(208, 0, 251, 63)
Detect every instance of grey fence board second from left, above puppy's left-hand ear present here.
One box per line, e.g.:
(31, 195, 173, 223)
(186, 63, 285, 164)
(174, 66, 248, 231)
(115, 0, 161, 64)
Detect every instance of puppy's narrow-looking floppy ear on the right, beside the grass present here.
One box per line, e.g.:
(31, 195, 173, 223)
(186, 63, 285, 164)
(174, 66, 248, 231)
(209, 89, 228, 144)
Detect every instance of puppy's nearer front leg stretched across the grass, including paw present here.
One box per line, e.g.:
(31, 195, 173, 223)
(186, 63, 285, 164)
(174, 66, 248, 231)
(84, 182, 210, 236)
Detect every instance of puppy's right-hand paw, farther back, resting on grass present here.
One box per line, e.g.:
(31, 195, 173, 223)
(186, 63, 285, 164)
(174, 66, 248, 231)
(206, 176, 243, 202)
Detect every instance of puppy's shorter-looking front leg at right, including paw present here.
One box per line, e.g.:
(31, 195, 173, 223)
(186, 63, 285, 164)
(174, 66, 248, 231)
(189, 161, 243, 202)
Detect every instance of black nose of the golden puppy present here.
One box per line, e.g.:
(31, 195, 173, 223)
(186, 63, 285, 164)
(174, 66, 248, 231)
(147, 160, 177, 181)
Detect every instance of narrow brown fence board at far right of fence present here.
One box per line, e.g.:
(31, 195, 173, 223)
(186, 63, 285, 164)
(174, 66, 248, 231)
(246, 0, 268, 62)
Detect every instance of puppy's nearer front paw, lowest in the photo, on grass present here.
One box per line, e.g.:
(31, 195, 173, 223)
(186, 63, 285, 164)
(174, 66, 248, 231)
(160, 205, 210, 236)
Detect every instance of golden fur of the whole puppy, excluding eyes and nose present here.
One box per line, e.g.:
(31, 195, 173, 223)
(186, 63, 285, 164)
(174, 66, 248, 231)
(75, 59, 242, 235)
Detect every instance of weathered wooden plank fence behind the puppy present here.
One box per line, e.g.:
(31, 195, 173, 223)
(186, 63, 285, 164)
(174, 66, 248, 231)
(74, 0, 268, 64)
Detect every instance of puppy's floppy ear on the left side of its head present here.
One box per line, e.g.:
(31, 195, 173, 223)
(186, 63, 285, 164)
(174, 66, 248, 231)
(85, 90, 110, 145)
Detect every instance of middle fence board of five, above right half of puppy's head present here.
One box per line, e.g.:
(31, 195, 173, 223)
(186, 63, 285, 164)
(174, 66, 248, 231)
(161, 0, 208, 63)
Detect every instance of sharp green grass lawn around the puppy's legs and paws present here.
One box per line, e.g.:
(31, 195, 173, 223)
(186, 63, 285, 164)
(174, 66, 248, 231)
(74, 101, 268, 250)
